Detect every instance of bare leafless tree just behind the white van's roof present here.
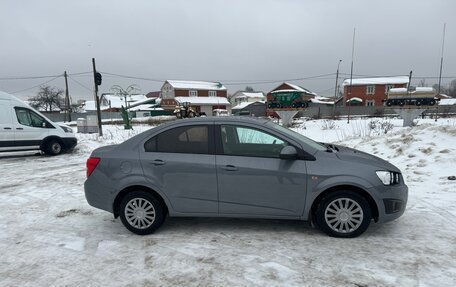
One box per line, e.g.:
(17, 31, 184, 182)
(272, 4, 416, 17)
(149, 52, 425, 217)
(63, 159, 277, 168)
(29, 86, 64, 112)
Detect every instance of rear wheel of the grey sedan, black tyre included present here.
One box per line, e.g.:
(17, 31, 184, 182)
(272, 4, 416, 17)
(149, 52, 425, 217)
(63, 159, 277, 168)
(120, 191, 165, 235)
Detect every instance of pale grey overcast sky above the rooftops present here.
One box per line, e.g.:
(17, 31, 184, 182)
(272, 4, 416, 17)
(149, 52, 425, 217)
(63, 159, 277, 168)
(0, 0, 456, 99)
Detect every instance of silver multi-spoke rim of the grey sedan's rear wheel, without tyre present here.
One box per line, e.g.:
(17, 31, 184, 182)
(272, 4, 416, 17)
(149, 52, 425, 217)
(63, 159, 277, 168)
(125, 198, 155, 229)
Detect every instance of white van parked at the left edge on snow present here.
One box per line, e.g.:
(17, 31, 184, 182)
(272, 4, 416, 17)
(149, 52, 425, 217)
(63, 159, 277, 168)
(0, 91, 77, 155)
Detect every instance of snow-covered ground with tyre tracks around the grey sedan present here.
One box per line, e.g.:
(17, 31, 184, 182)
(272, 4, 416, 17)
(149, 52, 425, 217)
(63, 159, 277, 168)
(0, 118, 456, 287)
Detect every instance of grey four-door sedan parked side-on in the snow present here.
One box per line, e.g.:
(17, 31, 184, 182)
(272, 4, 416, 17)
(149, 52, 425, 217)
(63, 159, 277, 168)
(84, 117, 408, 237)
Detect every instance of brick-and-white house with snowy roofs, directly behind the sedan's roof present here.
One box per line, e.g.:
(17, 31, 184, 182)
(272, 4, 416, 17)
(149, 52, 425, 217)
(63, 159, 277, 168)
(161, 80, 231, 115)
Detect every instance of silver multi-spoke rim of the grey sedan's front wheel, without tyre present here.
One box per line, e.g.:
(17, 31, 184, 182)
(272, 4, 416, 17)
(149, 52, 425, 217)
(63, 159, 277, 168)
(325, 198, 364, 233)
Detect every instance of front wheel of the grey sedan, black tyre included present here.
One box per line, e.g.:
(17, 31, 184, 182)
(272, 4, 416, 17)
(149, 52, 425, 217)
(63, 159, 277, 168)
(316, 191, 372, 238)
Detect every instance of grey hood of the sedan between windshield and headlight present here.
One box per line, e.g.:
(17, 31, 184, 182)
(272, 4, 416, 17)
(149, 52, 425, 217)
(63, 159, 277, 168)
(330, 145, 400, 172)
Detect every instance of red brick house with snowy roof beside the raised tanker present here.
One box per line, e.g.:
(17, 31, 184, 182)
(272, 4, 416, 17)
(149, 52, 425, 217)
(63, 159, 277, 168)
(343, 76, 409, 107)
